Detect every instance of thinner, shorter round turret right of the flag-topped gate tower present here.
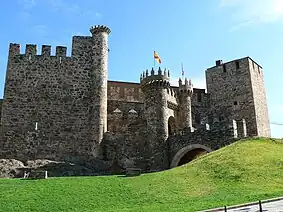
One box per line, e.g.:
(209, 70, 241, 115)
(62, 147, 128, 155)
(178, 78, 193, 130)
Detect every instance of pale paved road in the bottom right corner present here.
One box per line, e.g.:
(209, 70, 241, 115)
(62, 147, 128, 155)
(223, 200, 283, 212)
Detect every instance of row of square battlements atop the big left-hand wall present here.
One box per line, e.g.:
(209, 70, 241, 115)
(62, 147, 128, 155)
(9, 43, 70, 58)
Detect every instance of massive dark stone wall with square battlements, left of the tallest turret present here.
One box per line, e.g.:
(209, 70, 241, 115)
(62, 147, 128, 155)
(0, 28, 110, 159)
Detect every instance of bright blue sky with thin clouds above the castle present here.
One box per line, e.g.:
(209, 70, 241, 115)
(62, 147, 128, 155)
(0, 0, 283, 138)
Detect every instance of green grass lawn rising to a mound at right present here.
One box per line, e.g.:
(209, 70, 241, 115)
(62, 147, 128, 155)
(0, 139, 283, 212)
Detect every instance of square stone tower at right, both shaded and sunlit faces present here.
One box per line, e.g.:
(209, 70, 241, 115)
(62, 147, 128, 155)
(206, 57, 271, 137)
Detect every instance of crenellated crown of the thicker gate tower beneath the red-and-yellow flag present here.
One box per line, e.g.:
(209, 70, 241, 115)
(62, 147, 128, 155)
(140, 67, 170, 86)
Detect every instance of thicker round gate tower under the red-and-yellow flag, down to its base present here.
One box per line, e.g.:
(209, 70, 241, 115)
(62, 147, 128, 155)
(141, 68, 170, 170)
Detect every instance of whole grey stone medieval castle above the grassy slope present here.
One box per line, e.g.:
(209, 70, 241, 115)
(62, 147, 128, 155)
(0, 26, 270, 173)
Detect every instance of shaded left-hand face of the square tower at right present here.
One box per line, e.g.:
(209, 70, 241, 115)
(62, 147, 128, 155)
(206, 58, 257, 136)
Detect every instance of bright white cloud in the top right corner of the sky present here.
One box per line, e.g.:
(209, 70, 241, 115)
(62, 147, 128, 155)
(220, 0, 283, 31)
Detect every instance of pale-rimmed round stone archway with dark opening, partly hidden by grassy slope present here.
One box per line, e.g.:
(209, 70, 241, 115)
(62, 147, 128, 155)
(170, 144, 213, 168)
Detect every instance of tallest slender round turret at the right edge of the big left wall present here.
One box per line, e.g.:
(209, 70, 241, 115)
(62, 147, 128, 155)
(90, 25, 111, 147)
